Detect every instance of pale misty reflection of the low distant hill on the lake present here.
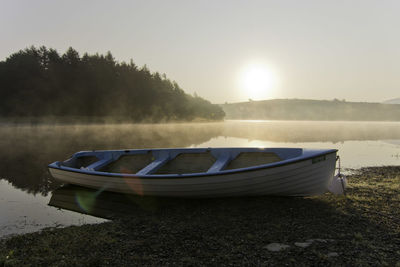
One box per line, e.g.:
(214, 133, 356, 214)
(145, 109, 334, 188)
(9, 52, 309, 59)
(222, 121, 400, 143)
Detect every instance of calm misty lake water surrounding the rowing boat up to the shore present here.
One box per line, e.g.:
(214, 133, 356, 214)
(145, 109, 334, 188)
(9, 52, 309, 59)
(0, 121, 400, 238)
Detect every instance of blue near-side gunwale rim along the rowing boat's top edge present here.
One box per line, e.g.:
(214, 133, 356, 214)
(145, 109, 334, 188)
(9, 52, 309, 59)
(48, 149, 338, 179)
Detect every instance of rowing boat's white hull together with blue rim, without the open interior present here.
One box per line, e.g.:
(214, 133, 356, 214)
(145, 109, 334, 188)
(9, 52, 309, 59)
(49, 148, 337, 198)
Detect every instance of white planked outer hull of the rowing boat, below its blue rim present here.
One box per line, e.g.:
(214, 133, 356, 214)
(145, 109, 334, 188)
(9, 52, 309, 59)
(49, 153, 336, 198)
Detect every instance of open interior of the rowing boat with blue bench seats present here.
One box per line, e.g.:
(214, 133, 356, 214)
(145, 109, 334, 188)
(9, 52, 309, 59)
(61, 148, 302, 175)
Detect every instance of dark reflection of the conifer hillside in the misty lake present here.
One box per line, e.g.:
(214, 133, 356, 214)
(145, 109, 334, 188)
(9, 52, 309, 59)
(0, 123, 221, 195)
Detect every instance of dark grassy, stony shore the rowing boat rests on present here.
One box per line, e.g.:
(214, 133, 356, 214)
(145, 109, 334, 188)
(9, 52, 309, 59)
(0, 167, 400, 266)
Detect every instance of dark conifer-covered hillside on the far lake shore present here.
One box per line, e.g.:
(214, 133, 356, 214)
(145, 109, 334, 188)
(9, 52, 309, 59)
(0, 46, 225, 122)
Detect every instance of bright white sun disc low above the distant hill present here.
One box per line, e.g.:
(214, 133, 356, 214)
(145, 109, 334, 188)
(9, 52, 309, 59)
(241, 64, 276, 100)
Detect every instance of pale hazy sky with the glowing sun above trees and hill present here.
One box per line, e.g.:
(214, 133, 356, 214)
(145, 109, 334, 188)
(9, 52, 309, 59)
(0, 0, 400, 103)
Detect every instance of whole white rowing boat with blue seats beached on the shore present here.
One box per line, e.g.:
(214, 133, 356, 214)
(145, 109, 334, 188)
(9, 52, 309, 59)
(48, 148, 337, 198)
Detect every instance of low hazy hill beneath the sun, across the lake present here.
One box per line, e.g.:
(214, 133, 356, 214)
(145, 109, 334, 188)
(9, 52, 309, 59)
(221, 99, 400, 121)
